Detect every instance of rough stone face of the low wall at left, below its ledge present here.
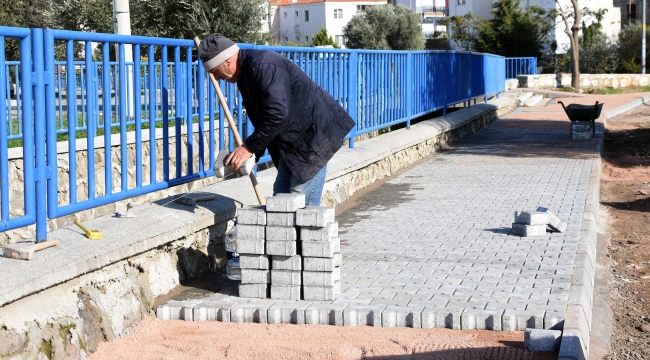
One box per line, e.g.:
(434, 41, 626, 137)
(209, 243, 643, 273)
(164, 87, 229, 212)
(0, 222, 232, 360)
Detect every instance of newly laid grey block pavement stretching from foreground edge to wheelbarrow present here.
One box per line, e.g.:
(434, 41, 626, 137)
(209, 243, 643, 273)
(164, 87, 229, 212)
(159, 122, 596, 331)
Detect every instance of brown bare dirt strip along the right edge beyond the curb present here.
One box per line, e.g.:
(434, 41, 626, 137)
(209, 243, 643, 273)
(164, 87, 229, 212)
(600, 106, 650, 360)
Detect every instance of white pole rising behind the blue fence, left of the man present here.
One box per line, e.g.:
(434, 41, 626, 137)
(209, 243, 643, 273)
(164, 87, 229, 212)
(113, 0, 134, 117)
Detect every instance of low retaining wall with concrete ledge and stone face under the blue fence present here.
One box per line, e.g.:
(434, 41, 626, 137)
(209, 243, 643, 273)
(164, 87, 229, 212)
(0, 97, 516, 359)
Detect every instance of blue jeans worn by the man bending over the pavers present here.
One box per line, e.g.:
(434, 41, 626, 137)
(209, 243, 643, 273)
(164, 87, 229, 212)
(273, 158, 327, 206)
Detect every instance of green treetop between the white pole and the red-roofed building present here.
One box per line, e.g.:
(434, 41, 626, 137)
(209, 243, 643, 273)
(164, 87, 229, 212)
(130, 0, 271, 44)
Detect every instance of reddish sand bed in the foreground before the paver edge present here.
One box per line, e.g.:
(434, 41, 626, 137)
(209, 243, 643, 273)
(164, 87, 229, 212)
(90, 318, 557, 360)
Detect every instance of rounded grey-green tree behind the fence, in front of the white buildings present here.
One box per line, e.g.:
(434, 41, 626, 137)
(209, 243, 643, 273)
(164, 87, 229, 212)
(343, 5, 425, 50)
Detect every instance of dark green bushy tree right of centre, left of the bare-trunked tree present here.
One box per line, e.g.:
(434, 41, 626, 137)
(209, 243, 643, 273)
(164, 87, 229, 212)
(473, 0, 553, 58)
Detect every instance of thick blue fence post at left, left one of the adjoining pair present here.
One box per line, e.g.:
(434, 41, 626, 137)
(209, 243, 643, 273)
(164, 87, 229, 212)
(31, 29, 47, 243)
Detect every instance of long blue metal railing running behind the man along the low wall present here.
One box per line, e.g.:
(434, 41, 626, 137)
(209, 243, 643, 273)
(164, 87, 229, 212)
(0, 27, 505, 241)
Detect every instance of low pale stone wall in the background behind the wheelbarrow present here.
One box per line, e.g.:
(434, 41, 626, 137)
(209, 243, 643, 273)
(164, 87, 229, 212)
(517, 74, 650, 89)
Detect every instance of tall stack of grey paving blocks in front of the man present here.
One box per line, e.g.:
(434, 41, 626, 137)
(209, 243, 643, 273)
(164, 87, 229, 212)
(237, 194, 341, 301)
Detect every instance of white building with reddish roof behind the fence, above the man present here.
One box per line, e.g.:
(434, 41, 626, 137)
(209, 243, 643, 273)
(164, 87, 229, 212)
(270, 0, 387, 48)
